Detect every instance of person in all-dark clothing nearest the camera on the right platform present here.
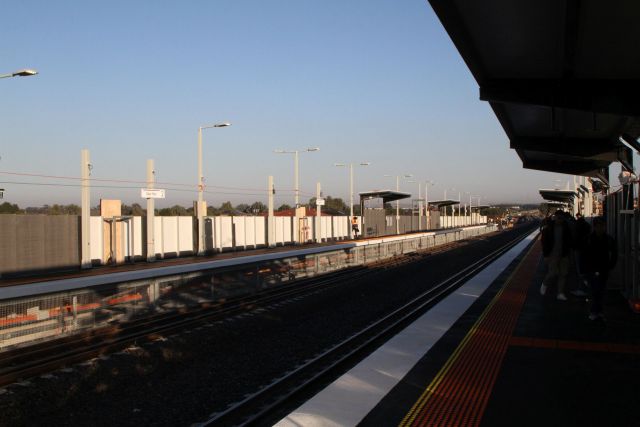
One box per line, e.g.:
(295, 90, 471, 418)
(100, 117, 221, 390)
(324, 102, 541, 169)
(584, 217, 618, 320)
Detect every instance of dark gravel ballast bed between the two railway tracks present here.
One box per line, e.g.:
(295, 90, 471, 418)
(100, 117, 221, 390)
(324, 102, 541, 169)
(0, 228, 536, 426)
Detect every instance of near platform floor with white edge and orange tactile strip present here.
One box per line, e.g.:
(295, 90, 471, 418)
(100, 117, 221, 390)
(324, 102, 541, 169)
(278, 235, 640, 426)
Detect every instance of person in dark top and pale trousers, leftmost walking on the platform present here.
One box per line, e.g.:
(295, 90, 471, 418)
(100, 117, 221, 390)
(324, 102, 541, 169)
(540, 210, 572, 301)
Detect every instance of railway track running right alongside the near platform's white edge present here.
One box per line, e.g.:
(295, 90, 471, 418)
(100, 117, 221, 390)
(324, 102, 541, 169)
(198, 226, 529, 426)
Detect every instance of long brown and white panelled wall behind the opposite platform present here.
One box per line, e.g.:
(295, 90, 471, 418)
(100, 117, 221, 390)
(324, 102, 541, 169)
(0, 210, 486, 275)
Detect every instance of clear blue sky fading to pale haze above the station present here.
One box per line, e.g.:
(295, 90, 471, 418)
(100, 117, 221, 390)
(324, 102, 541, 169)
(0, 0, 580, 206)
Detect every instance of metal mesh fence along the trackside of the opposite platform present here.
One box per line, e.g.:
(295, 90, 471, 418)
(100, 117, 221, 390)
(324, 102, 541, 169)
(0, 226, 495, 351)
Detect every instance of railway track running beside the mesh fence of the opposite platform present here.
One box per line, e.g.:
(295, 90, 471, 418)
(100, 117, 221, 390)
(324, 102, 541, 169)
(0, 232, 484, 387)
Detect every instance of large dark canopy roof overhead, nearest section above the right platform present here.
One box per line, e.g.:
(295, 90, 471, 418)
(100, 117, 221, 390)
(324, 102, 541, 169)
(429, 0, 640, 179)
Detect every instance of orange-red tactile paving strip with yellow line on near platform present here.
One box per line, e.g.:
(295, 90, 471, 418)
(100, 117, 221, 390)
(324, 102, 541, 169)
(400, 239, 541, 427)
